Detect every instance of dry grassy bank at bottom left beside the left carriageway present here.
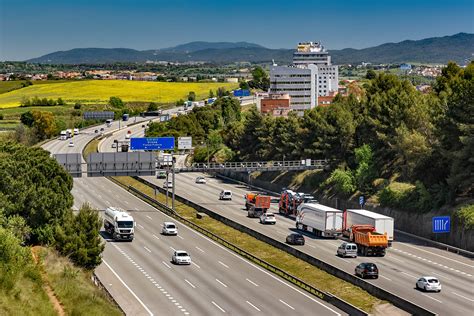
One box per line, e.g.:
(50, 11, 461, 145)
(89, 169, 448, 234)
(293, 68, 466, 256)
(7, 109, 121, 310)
(40, 248, 122, 316)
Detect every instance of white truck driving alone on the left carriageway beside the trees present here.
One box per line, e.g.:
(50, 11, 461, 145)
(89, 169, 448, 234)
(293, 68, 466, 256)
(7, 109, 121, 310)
(104, 207, 135, 241)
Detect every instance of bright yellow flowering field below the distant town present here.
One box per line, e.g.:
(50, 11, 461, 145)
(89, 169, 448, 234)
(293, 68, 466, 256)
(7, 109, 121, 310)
(0, 80, 237, 108)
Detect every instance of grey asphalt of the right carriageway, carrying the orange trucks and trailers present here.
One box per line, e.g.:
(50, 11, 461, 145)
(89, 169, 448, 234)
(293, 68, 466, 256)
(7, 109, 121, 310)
(100, 123, 474, 315)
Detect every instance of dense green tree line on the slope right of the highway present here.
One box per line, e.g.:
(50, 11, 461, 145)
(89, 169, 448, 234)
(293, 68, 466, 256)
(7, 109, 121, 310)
(148, 62, 474, 215)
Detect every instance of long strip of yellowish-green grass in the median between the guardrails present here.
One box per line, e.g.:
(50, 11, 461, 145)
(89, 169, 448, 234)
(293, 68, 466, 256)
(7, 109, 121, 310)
(114, 177, 386, 312)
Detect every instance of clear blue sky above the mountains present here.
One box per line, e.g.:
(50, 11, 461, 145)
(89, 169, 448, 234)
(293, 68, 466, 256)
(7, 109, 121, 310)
(0, 0, 474, 60)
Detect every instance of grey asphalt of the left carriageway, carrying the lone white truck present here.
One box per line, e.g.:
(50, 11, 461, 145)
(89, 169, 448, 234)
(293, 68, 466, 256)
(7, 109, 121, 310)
(43, 117, 343, 315)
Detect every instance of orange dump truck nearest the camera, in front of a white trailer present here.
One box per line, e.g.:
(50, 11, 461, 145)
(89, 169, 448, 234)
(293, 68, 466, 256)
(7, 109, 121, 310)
(350, 225, 388, 257)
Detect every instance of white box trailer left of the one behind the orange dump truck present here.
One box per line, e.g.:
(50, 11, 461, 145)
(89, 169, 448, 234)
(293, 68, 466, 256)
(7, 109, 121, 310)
(296, 203, 343, 237)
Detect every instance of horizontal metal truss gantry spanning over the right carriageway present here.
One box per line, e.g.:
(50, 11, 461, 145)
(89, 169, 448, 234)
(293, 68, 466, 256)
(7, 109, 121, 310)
(176, 159, 329, 172)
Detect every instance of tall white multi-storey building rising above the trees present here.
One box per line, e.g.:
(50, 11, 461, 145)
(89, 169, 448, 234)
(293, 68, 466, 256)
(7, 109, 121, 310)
(270, 42, 339, 111)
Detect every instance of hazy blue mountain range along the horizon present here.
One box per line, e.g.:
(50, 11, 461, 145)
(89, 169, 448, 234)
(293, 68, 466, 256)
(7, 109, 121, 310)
(27, 33, 474, 64)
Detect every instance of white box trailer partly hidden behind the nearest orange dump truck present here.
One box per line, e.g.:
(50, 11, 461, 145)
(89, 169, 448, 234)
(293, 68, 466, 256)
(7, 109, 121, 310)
(344, 209, 394, 244)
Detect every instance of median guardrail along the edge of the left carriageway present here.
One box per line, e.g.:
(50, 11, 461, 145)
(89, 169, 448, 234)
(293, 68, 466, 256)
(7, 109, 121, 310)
(108, 178, 368, 316)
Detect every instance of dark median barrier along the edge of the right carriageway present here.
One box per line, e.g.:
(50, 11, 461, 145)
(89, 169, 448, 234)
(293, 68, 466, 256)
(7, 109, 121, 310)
(134, 177, 437, 315)
